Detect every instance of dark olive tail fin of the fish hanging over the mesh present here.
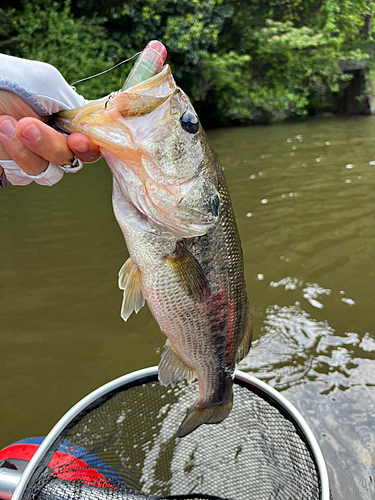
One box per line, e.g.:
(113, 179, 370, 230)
(177, 393, 233, 437)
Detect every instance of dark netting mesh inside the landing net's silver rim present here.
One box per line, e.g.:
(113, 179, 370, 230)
(22, 375, 332, 500)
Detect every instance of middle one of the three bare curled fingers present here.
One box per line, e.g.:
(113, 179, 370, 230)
(16, 117, 74, 165)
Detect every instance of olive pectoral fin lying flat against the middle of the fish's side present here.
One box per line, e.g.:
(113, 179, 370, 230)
(168, 242, 210, 302)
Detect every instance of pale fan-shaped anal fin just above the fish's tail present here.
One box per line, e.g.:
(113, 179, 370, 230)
(159, 340, 196, 386)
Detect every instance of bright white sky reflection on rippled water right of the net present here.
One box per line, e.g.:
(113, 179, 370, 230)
(239, 277, 375, 499)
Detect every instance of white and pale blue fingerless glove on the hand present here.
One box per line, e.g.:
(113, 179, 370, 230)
(0, 54, 87, 186)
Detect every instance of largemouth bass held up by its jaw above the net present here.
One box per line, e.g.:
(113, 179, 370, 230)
(56, 58, 252, 437)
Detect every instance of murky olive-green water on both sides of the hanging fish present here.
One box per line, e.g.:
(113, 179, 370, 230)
(0, 118, 375, 500)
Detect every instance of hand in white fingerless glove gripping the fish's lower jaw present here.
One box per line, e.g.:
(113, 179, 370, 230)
(0, 54, 100, 187)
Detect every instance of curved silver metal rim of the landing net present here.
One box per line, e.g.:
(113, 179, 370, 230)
(12, 366, 330, 500)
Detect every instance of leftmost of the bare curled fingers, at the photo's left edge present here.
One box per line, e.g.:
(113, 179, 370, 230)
(0, 115, 48, 175)
